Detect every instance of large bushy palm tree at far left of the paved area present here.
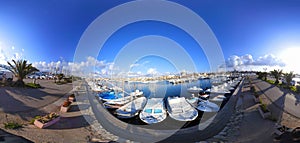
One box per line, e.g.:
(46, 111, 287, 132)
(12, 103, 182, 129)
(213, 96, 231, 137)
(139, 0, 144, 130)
(7, 60, 39, 87)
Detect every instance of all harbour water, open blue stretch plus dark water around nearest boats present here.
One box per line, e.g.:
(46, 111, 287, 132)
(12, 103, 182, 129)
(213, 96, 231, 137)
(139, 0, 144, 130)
(104, 79, 234, 130)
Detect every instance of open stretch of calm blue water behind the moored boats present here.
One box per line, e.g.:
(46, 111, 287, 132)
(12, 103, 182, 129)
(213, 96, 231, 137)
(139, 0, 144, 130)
(105, 79, 211, 98)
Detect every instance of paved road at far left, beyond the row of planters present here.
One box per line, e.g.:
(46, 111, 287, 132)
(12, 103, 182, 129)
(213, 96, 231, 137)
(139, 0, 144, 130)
(0, 79, 72, 113)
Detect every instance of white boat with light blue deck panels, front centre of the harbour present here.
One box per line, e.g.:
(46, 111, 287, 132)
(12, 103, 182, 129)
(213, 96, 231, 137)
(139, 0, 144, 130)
(139, 98, 167, 124)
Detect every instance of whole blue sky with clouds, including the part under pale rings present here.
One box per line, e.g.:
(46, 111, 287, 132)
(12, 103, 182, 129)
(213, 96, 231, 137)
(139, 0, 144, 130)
(0, 0, 300, 74)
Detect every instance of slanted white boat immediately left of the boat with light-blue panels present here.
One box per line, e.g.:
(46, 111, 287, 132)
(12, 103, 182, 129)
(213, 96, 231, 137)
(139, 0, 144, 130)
(116, 97, 147, 118)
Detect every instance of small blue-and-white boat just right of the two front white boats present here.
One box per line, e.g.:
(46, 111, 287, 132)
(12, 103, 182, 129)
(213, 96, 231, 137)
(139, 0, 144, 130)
(197, 98, 220, 112)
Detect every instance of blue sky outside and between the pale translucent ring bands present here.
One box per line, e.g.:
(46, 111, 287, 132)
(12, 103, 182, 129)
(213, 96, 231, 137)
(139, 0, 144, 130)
(0, 0, 300, 73)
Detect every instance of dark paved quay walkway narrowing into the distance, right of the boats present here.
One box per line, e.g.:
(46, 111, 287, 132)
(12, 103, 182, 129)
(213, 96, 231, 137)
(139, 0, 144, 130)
(207, 80, 275, 143)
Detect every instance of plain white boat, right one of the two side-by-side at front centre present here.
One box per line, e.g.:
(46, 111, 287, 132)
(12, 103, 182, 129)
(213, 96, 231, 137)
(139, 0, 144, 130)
(167, 97, 198, 121)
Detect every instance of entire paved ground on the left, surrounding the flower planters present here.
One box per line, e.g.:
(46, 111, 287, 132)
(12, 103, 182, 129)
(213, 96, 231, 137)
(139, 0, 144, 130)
(0, 80, 115, 143)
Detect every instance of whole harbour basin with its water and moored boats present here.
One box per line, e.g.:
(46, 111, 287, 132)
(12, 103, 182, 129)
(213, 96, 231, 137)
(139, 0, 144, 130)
(88, 76, 242, 130)
